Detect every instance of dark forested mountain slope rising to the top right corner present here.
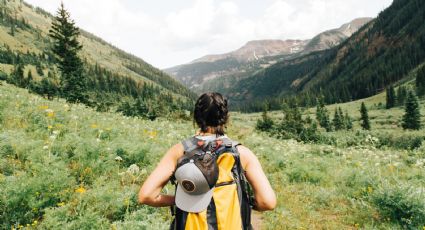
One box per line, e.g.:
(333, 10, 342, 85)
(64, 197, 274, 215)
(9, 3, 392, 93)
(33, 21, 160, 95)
(219, 0, 425, 110)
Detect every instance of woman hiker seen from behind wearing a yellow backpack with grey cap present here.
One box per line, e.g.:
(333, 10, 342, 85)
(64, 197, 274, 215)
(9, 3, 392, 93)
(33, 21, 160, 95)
(139, 93, 276, 230)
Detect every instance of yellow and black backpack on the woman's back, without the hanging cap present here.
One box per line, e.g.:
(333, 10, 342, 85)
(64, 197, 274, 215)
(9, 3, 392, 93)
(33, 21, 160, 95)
(170, 136, 252, 230)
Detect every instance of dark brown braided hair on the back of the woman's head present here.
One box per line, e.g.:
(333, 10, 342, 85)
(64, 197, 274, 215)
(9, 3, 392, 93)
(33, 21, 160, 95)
(193, 93, 229, 135)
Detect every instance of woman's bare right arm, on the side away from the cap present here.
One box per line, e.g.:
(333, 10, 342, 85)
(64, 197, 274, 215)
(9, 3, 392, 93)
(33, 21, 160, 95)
(237, 145, 276, 211)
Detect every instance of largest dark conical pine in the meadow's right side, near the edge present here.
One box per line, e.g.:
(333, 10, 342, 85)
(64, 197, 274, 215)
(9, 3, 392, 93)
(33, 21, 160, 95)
(402, 91, 421, 130)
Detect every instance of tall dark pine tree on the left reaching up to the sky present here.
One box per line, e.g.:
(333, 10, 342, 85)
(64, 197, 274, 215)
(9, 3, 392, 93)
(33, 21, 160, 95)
(49, 3, 87, 103)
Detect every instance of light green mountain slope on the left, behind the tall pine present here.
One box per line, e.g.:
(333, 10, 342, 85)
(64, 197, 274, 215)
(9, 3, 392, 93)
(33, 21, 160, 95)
(0, 0, 196, 113)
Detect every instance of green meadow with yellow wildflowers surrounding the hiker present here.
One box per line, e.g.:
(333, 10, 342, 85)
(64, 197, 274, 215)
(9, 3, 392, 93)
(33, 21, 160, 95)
(0, 82, 425, 229)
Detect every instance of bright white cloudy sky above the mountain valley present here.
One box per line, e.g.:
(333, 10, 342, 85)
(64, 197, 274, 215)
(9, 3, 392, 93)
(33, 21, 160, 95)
(25, 0, 392, 68)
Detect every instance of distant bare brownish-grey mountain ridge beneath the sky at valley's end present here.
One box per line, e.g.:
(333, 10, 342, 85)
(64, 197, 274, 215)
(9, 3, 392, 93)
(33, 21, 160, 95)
(164, 18, 371, 93)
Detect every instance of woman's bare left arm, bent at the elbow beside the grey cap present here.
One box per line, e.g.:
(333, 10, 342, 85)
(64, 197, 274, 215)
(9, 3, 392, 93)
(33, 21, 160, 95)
(139, 143, 183, 207)
